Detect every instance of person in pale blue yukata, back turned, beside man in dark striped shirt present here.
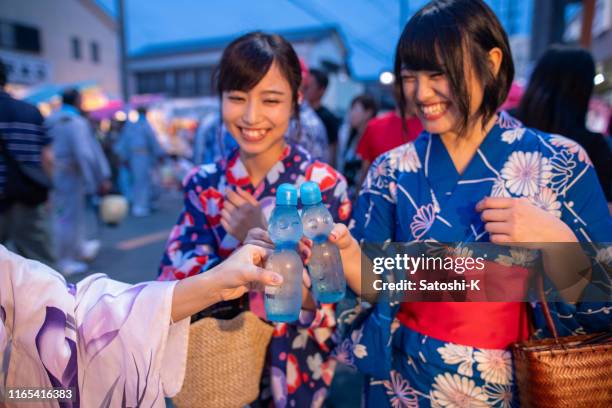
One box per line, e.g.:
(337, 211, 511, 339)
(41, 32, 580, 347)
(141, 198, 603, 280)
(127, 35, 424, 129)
(45, 89, 110, 276)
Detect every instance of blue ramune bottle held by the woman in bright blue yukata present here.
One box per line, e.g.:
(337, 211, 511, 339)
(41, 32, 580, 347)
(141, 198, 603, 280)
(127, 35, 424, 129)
(300, 181, 346, 303)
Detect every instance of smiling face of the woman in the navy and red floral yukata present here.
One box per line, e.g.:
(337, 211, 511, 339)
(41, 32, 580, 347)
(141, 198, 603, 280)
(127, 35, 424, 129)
(222, 63, 293, 155)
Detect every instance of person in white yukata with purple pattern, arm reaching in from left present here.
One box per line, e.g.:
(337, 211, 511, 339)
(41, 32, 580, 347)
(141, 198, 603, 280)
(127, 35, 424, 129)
(0, 245, 282, 407)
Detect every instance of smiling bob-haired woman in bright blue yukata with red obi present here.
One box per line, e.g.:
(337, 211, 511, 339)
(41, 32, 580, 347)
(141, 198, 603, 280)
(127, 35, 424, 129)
(306, 0, 612, 407)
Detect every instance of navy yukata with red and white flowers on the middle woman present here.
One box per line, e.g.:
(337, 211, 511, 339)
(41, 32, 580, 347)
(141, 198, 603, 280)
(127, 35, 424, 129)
(160, 145, 351, 407)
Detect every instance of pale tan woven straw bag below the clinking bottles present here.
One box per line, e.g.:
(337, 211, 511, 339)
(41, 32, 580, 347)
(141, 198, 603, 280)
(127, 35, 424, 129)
(172, 311, 274, 408)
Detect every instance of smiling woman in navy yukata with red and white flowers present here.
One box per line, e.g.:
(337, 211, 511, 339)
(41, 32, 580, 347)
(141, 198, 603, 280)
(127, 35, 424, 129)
(155, 32, 351, 407)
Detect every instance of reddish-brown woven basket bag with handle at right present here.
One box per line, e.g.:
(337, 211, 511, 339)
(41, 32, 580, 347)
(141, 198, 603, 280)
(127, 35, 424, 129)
(512, 279, 612, 408)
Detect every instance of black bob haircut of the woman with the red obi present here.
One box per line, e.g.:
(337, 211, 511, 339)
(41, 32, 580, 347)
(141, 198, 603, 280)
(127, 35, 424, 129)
(395, 0, 514, 134)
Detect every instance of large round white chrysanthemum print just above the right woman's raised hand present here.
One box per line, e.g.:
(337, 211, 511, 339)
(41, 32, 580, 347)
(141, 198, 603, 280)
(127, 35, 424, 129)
(501, 151, 550, 196)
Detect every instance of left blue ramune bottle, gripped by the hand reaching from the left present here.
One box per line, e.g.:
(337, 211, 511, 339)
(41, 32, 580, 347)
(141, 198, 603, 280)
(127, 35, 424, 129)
(265, 183, 304, 322)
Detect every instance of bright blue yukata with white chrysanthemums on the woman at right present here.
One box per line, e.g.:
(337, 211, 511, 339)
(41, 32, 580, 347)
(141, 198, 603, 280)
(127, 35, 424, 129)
(335, 112, 612, 408)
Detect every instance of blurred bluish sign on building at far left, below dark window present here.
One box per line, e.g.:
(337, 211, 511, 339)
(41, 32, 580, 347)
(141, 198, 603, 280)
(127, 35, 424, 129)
(0, 51, 51, 85)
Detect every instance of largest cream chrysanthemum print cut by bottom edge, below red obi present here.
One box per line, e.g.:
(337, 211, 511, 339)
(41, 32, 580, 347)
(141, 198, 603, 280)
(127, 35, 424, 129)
(430, 373, 489, 408)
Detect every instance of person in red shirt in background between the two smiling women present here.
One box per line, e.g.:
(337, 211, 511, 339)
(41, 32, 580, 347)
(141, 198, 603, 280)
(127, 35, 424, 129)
(356, 84, 423, 186)
